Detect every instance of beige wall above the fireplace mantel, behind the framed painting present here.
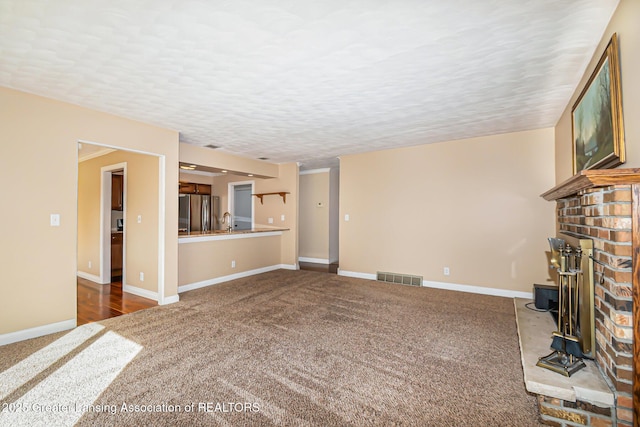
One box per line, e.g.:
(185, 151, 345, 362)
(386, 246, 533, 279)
(555, 0, 640, 183)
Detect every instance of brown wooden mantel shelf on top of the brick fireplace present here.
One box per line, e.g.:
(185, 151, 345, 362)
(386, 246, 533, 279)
(540, 168, 640, 201)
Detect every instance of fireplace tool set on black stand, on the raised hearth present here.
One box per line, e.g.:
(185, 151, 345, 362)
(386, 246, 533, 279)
(536, 238, 586, 377)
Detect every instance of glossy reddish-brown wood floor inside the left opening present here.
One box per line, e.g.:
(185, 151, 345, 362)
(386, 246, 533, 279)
(77, 277, 158, 326)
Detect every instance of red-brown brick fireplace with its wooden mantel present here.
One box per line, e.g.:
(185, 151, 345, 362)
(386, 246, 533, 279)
(539, 169, 640, 426)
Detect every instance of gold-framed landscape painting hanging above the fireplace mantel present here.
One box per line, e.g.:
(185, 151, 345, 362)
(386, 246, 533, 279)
(571, 33, 625, 174)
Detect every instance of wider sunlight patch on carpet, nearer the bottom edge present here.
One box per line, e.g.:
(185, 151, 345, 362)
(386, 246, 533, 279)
(0, 331, 142, 426)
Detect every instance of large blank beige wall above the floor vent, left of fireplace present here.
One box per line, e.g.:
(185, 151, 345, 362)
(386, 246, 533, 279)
(340, 129, 555, 292)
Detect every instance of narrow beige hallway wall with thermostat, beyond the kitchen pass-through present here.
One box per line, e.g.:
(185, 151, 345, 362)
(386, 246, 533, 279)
(299, 169, 330, 261)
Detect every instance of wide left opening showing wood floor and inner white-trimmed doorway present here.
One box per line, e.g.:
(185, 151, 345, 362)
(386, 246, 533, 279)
(77, 142, 164, 323)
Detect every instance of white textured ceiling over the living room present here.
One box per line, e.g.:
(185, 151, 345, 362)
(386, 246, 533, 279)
(0, 0, 618, 169)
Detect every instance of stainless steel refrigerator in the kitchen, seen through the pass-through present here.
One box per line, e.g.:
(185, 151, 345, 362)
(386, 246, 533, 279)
(178, 194, 220, 234)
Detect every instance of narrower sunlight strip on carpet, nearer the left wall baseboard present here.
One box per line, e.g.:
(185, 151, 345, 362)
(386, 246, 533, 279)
(0, 323, 104, 399)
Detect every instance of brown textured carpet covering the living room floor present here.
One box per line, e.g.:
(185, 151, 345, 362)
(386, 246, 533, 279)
(0, 270, 540, 427)
